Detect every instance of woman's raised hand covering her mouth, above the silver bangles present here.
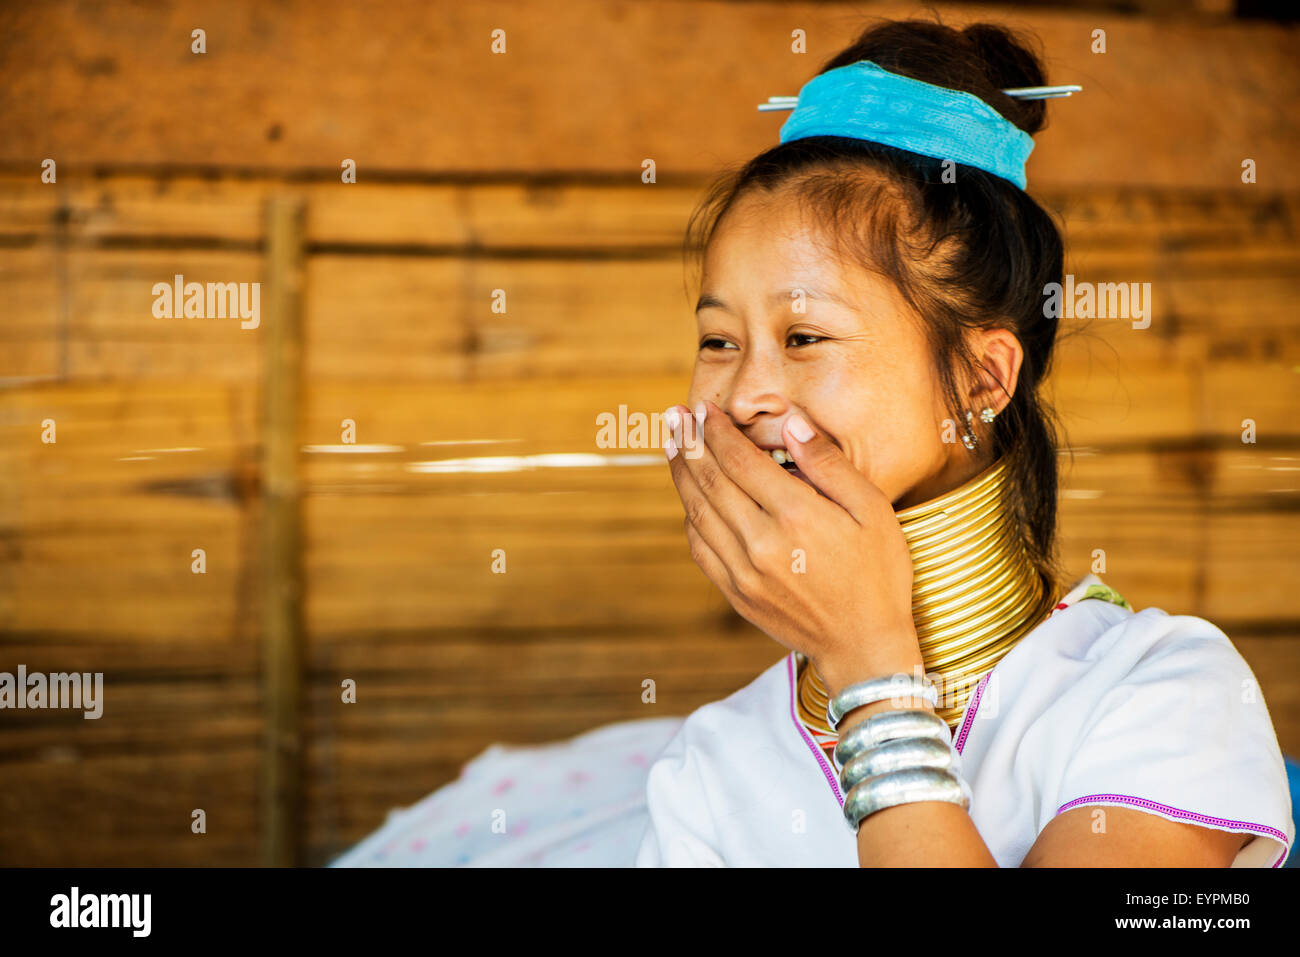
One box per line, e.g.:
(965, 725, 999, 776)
(666, 402, 923, 696)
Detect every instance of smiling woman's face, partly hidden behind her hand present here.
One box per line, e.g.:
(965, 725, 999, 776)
(689, 194, 985, 508)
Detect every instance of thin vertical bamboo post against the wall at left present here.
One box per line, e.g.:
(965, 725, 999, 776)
(259, 196, 304, 867)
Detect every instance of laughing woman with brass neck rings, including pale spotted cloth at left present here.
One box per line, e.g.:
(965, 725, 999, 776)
(335, 16, 1295, 866)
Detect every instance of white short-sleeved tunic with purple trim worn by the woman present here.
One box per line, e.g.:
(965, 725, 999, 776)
(637, 575, 1295, 867)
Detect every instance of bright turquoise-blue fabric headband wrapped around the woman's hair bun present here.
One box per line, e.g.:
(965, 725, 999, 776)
(781, 60, 1034, 190)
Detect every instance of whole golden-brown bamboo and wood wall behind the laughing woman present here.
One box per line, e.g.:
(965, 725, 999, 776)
(0, 0, 1300, 865)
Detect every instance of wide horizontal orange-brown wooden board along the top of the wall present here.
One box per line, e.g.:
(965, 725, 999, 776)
(0, 0, 1300, 188)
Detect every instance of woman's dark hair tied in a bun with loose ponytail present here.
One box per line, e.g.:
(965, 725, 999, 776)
(686, 14, 1065, 598)
